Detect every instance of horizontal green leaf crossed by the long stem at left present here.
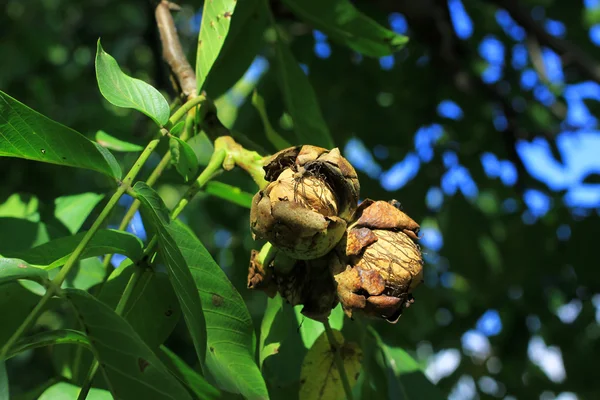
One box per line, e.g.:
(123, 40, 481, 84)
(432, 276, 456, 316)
(4, 229, 143, 270)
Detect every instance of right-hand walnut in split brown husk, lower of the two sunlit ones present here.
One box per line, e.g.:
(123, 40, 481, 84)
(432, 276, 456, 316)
(330, 199, 423, 323)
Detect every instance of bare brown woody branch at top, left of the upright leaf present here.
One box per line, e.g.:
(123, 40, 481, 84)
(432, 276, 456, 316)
(155, 0, 196, 99)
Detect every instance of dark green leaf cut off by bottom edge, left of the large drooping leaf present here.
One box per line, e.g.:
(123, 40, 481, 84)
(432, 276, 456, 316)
(64, 289, 190, 400)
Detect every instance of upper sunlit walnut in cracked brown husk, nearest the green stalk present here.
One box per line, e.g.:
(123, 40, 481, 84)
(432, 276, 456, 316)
(250, 145, 360, 260)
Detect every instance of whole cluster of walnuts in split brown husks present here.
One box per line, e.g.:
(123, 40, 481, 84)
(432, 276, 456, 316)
(248, 146, 423, 323)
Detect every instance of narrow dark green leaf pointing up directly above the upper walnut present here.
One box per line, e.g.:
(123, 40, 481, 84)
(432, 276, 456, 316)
(266, 13, 334, 149)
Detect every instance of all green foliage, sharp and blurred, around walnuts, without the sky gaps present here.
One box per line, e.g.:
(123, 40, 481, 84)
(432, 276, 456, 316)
(0, 0, 600, 400)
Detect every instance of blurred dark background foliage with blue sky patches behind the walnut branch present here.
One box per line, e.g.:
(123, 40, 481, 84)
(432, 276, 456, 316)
(0, 0, 600, 400)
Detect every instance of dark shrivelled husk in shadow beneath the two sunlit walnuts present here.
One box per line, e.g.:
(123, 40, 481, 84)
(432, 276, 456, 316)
(248, 250, 338, 322)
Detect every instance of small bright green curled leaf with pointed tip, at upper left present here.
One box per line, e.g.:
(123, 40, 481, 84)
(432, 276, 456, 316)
(96, 39, 171, 126)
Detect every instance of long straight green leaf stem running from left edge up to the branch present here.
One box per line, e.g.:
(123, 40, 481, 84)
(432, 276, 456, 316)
(0, 139, 159, 360)
